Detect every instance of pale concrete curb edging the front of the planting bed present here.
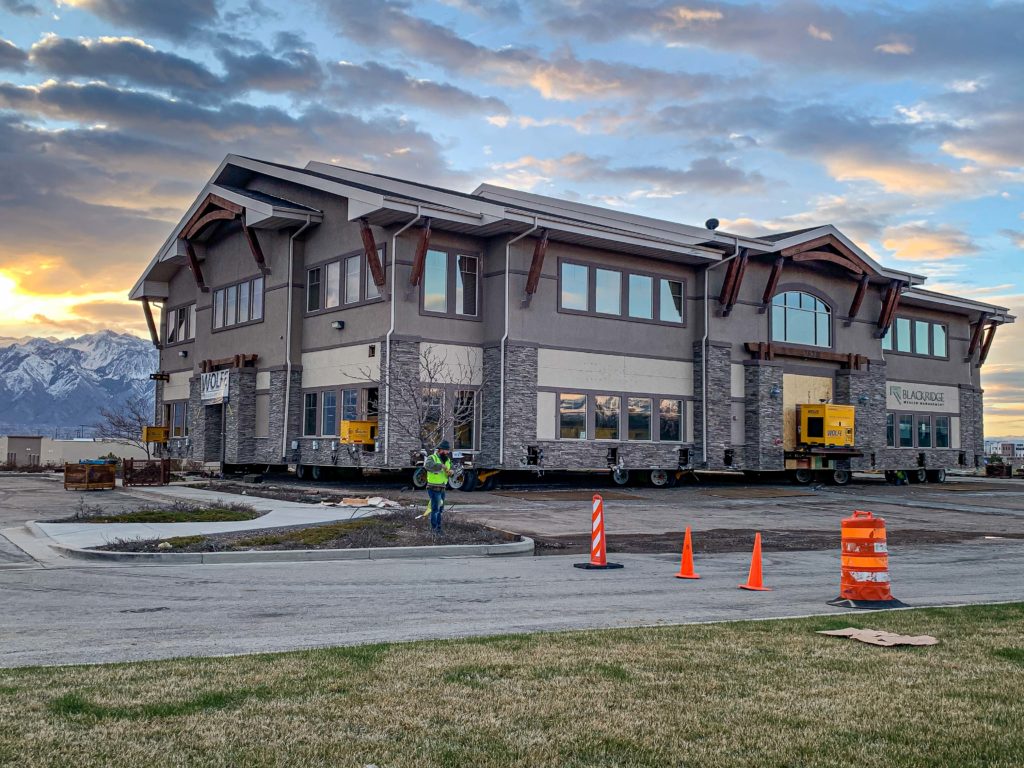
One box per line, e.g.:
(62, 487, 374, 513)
(48, 531, 534, 565)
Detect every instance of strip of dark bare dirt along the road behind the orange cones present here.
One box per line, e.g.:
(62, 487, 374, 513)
(525, 528, 1024, 555)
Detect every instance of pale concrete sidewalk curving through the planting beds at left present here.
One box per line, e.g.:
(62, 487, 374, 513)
(35, 485, 386, 549)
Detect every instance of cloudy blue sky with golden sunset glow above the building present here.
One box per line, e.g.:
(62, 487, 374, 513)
(0, 0, 1024, 435)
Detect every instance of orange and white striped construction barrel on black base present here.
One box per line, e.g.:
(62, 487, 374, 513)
(829, 509, 903, 608)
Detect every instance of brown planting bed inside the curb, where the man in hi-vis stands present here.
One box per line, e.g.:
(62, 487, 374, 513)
(96, 510, 521, 552)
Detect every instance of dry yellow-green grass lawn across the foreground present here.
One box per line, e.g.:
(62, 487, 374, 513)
(0, 603, 1024, 768)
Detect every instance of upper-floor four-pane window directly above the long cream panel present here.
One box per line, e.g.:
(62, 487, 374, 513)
(558, 261, 686, 326)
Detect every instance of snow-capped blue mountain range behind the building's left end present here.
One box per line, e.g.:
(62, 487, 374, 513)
(0, 331, 160, 435)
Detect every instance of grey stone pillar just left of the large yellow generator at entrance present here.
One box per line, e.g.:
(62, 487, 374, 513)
(743, 360, 785, 471)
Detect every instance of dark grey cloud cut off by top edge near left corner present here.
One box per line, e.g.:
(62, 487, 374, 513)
(58, 0, 218, 40)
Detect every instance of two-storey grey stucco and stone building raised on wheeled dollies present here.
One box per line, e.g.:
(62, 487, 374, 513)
(131, 156, 1014, 488)
